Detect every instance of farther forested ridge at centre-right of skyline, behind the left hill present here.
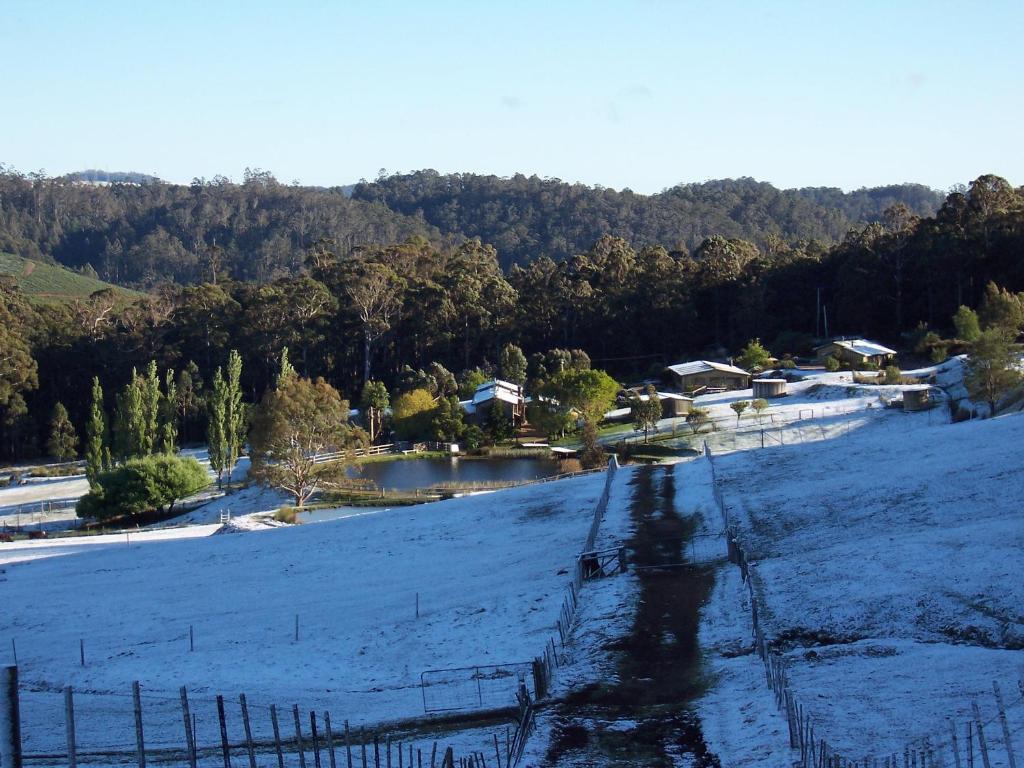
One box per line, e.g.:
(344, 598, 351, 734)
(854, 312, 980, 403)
(352, 171, 942, 267)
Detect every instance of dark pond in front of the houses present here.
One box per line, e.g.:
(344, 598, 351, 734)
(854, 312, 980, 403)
(352, 458, 558, 490)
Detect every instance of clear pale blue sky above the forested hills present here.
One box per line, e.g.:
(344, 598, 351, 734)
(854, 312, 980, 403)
(0, 0, 1024, 193)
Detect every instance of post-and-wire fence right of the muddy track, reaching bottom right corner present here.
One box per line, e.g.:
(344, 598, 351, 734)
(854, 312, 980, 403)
(703, 442, 1024, 768)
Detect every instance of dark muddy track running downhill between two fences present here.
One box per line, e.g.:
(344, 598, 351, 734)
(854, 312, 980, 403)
(545, 466, 719, 768)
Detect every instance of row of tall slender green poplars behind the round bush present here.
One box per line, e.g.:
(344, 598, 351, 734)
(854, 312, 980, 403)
(85, 349, 248, 486)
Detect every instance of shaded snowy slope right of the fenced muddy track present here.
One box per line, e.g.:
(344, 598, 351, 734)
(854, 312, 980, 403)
(710, 412, 1024, 765)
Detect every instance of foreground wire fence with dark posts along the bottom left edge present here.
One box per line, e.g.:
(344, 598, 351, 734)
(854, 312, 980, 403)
(12, 683, 507, 768)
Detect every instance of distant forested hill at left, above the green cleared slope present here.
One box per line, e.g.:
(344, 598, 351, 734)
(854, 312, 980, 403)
(0, 165, 438, 288)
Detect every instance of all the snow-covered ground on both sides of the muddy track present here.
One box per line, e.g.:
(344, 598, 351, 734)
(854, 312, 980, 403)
(0, 360, 1024, 768)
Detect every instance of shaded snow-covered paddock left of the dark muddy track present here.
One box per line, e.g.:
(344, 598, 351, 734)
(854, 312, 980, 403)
(0, 474, 604, 752)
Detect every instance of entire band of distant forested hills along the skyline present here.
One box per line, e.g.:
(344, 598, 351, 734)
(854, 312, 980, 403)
(0, 166, 942, 288)
